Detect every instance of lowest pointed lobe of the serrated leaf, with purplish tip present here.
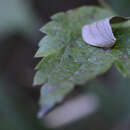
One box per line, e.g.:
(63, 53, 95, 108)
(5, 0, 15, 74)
(38, 82, 74, 118)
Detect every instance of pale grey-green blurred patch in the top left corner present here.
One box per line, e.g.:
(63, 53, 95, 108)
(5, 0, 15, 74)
(0, 0, 39, 37)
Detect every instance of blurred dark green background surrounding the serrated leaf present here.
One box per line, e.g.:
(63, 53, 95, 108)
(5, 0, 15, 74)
(0, 0, 130, 130)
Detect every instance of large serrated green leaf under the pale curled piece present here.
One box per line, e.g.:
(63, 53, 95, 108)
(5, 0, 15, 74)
(34, 6, 130, 115)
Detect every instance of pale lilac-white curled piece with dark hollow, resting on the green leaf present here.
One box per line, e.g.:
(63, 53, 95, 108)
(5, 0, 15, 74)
(82, 16, 130, 48)
